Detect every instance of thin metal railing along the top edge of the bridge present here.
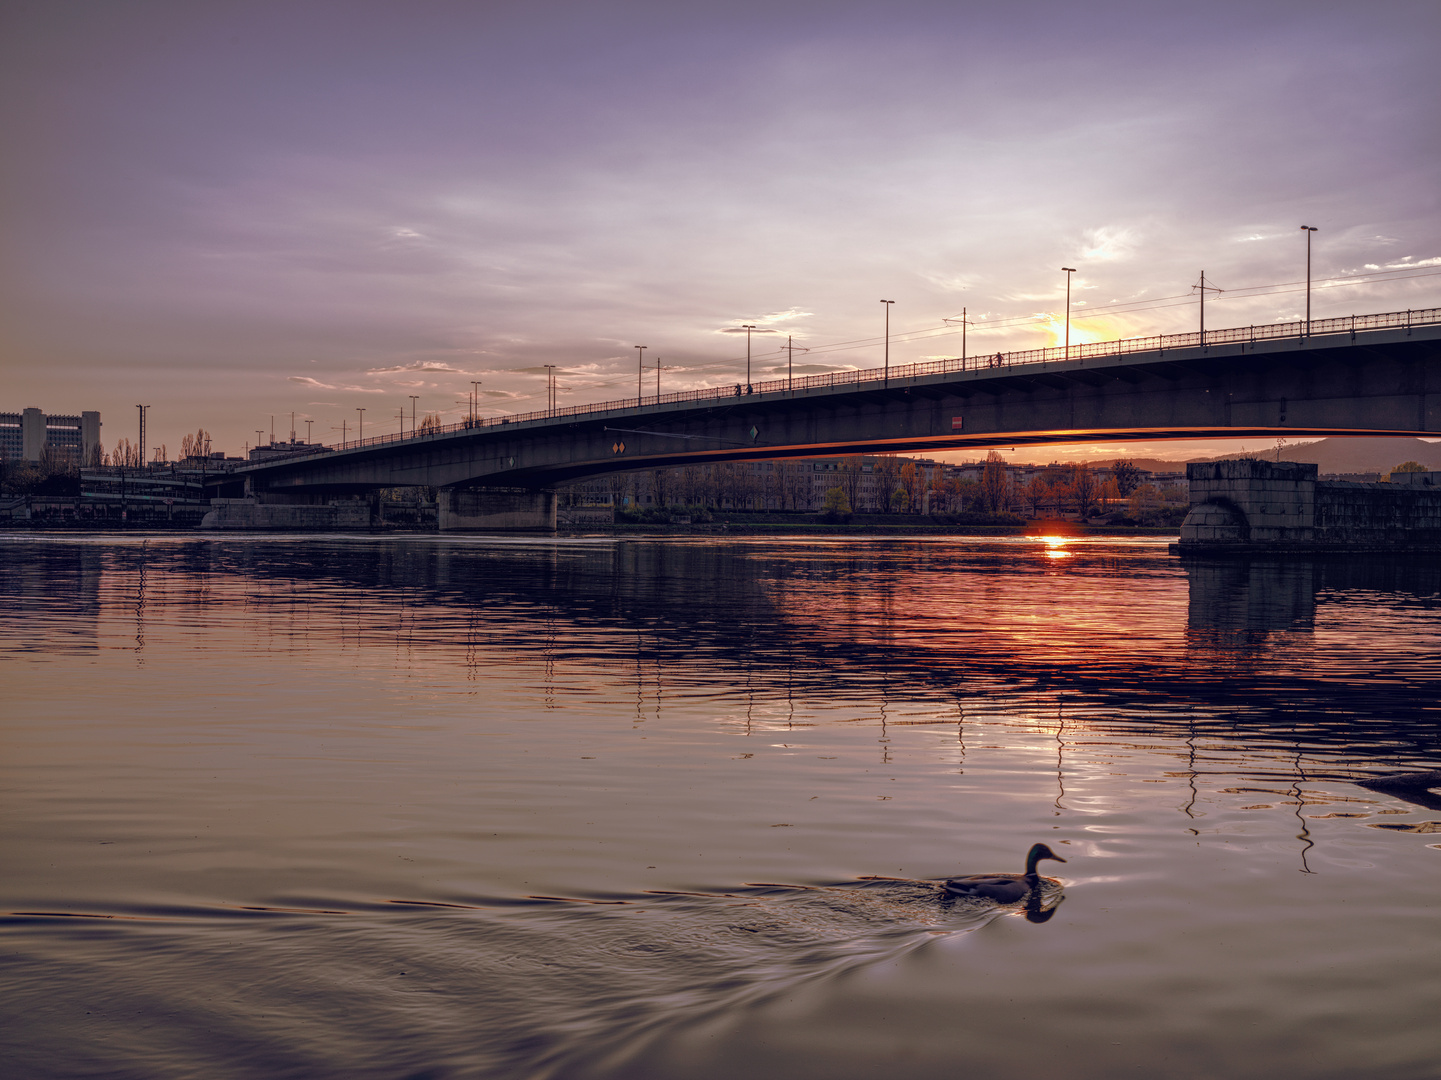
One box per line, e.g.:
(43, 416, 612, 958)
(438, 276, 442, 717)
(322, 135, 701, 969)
(272, 307, 1441, 461)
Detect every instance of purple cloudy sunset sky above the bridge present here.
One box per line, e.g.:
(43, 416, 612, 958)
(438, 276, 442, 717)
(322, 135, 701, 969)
(0, 0, 1441, 454)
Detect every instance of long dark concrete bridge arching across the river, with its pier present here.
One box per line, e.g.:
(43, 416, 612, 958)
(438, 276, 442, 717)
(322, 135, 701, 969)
(221, 309, 1441, 529)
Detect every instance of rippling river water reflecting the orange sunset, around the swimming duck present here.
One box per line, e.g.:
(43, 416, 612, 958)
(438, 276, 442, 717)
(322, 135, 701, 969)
(0, 535, 1441, 1080)
